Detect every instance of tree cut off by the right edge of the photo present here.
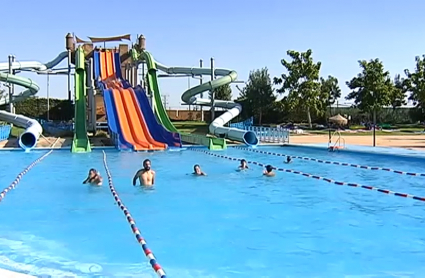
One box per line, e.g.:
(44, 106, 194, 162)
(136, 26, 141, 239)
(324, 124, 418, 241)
(404, 55, 425, 108)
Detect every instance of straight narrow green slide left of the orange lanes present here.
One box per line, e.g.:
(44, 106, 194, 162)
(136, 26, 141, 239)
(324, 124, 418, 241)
(71, 47, 91, 153)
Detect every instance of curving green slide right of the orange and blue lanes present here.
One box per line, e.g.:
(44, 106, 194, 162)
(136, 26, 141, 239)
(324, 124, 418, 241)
(137, 49, 227, 150)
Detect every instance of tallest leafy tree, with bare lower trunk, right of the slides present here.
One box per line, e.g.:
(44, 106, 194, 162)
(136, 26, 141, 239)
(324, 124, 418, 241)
(274, 49, 322, 128)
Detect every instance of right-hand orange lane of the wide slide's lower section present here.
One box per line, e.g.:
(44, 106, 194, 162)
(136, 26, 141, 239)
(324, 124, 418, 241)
(119, 88, 167, 150)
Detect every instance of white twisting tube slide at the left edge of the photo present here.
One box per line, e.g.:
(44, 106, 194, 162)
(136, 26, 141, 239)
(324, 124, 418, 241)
(0, 51, 68, 150)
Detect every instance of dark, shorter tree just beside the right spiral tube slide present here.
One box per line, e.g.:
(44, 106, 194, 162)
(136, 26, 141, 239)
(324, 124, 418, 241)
(237, 68, 276, 125)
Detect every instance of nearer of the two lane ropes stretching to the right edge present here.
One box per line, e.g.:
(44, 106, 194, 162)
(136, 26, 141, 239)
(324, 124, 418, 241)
(188, 148, 425, 202)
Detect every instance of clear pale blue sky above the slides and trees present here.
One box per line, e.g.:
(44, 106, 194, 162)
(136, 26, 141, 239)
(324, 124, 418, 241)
(0, 0, 425, 108)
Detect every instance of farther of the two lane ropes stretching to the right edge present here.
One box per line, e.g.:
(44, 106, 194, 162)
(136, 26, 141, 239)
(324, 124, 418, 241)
(232, 147, 425, 177)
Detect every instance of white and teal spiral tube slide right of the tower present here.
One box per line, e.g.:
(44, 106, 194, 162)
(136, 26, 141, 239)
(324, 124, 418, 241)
(138, 50, 258, 146)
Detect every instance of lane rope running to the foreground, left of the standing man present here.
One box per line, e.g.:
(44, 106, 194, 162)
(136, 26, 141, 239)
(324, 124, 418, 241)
(102, 151, 167, 278)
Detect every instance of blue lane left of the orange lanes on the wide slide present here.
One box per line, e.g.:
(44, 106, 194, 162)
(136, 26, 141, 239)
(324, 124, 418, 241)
(103, 89, 133, 150)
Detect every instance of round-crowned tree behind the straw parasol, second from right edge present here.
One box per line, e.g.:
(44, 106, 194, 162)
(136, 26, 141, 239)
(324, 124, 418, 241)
(346, 59, 394, 112)
